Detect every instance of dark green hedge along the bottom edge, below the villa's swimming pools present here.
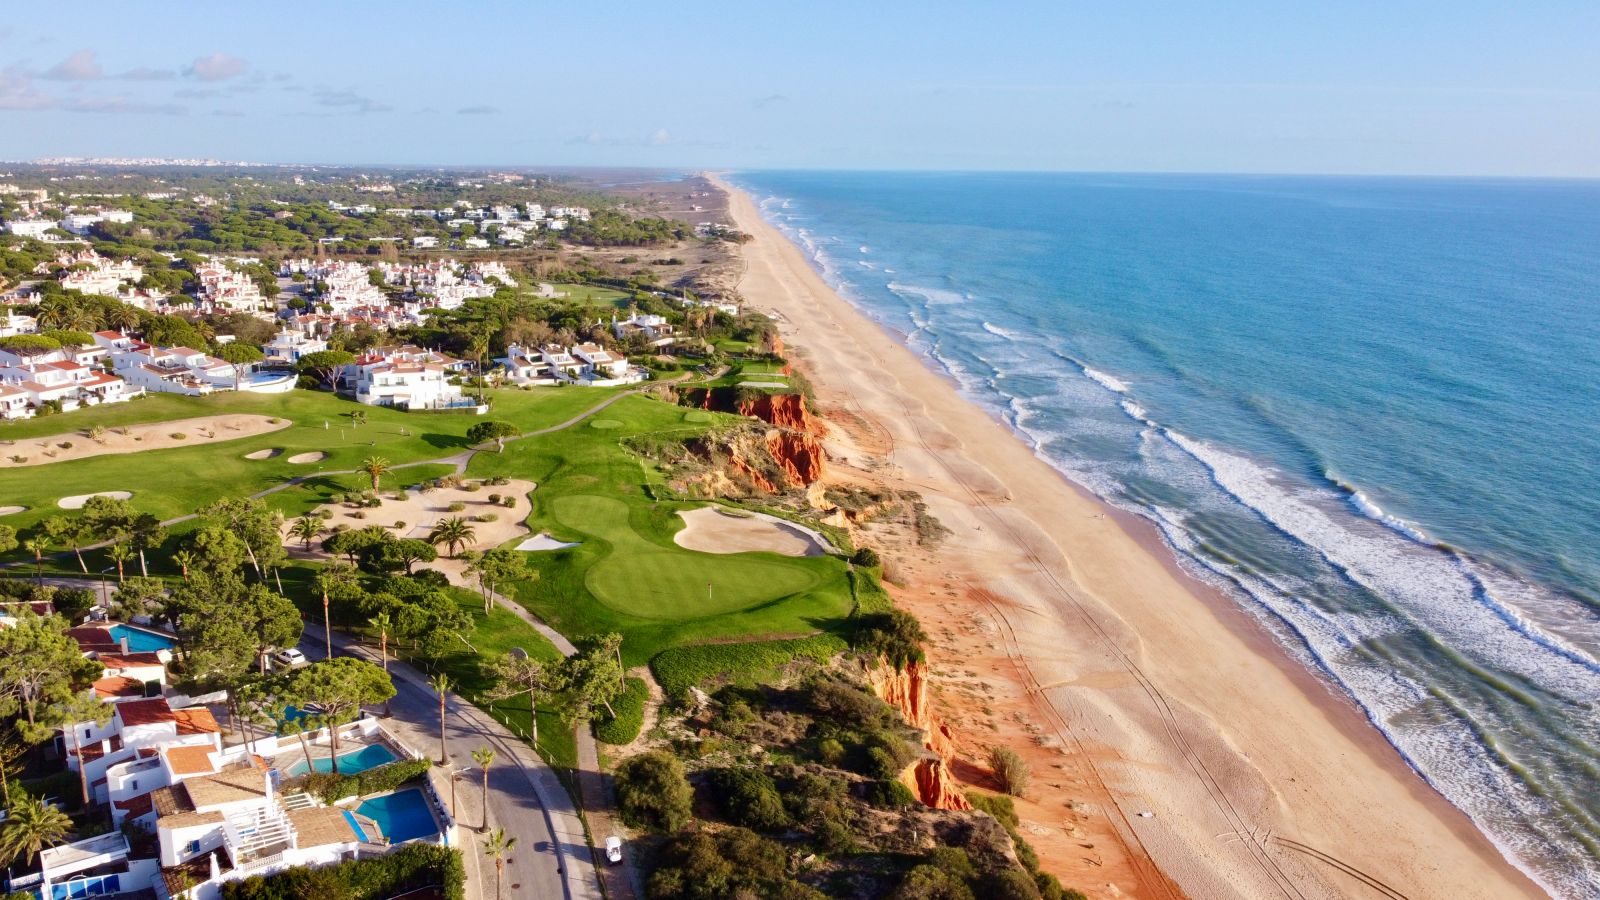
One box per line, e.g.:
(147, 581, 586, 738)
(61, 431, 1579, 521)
(222, 844, 467, 900)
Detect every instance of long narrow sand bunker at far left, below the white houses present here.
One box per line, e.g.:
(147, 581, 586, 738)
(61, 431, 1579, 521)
(0, 413, 294, 469)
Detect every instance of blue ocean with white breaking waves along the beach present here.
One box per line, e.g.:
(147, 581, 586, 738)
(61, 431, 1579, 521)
(733, 171, 1600, 897)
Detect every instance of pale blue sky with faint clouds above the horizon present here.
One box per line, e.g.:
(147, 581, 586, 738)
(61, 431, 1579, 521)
(0, 0, 1600, 178)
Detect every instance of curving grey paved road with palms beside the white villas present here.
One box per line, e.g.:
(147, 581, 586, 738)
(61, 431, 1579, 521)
(301, 625, 600, 900)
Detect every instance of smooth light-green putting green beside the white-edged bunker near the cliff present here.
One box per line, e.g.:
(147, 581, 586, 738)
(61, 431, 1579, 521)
(554, 495, 821, 620)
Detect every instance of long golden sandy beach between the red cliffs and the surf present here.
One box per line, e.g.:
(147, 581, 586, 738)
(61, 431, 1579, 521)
(718, 171, 1544, 898)
